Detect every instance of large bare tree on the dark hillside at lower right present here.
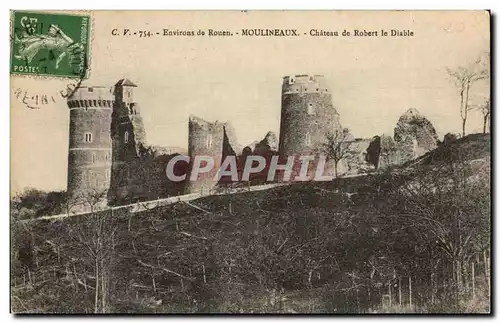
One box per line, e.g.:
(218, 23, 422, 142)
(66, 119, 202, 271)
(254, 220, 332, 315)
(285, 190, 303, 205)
(388, 158, 490, 301)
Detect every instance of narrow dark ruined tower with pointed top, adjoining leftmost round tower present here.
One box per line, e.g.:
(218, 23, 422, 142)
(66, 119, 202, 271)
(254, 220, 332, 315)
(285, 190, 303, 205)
(109, 79, 148, 202)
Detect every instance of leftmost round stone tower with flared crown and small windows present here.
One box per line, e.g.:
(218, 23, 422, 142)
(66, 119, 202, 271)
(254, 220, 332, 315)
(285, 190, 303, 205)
(67, 86, 114, 207)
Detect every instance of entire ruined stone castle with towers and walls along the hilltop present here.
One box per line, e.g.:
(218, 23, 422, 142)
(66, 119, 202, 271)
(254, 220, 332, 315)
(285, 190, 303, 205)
(67, 75, 437, 208)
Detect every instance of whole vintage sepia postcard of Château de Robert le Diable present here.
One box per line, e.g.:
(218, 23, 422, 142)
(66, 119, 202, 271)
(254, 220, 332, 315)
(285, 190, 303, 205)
(9, 10, 492, 314)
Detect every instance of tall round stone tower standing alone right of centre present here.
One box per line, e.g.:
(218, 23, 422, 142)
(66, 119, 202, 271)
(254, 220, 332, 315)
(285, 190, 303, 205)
(279, 75, 341, 158)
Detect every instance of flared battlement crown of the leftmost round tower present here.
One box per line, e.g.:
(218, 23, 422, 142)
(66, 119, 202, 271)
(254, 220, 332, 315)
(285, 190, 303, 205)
(68, 86, 115, 108)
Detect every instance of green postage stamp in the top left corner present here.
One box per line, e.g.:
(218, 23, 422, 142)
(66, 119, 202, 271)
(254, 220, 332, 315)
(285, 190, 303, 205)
(10, 11, 91, 79)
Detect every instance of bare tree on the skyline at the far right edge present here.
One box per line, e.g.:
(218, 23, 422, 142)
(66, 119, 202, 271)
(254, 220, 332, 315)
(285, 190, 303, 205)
(446, 57, 489, 136)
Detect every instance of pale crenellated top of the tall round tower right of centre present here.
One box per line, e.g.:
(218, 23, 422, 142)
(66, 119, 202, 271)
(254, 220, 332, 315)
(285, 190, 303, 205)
(282, 74, 329, 94)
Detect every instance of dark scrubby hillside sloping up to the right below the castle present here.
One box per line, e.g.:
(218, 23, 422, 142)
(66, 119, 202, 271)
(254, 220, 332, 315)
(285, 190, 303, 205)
(12, 135, 490, 313)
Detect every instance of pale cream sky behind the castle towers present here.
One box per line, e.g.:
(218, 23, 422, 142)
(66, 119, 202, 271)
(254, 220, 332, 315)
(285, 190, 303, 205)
(11, 11, 490, 192)
